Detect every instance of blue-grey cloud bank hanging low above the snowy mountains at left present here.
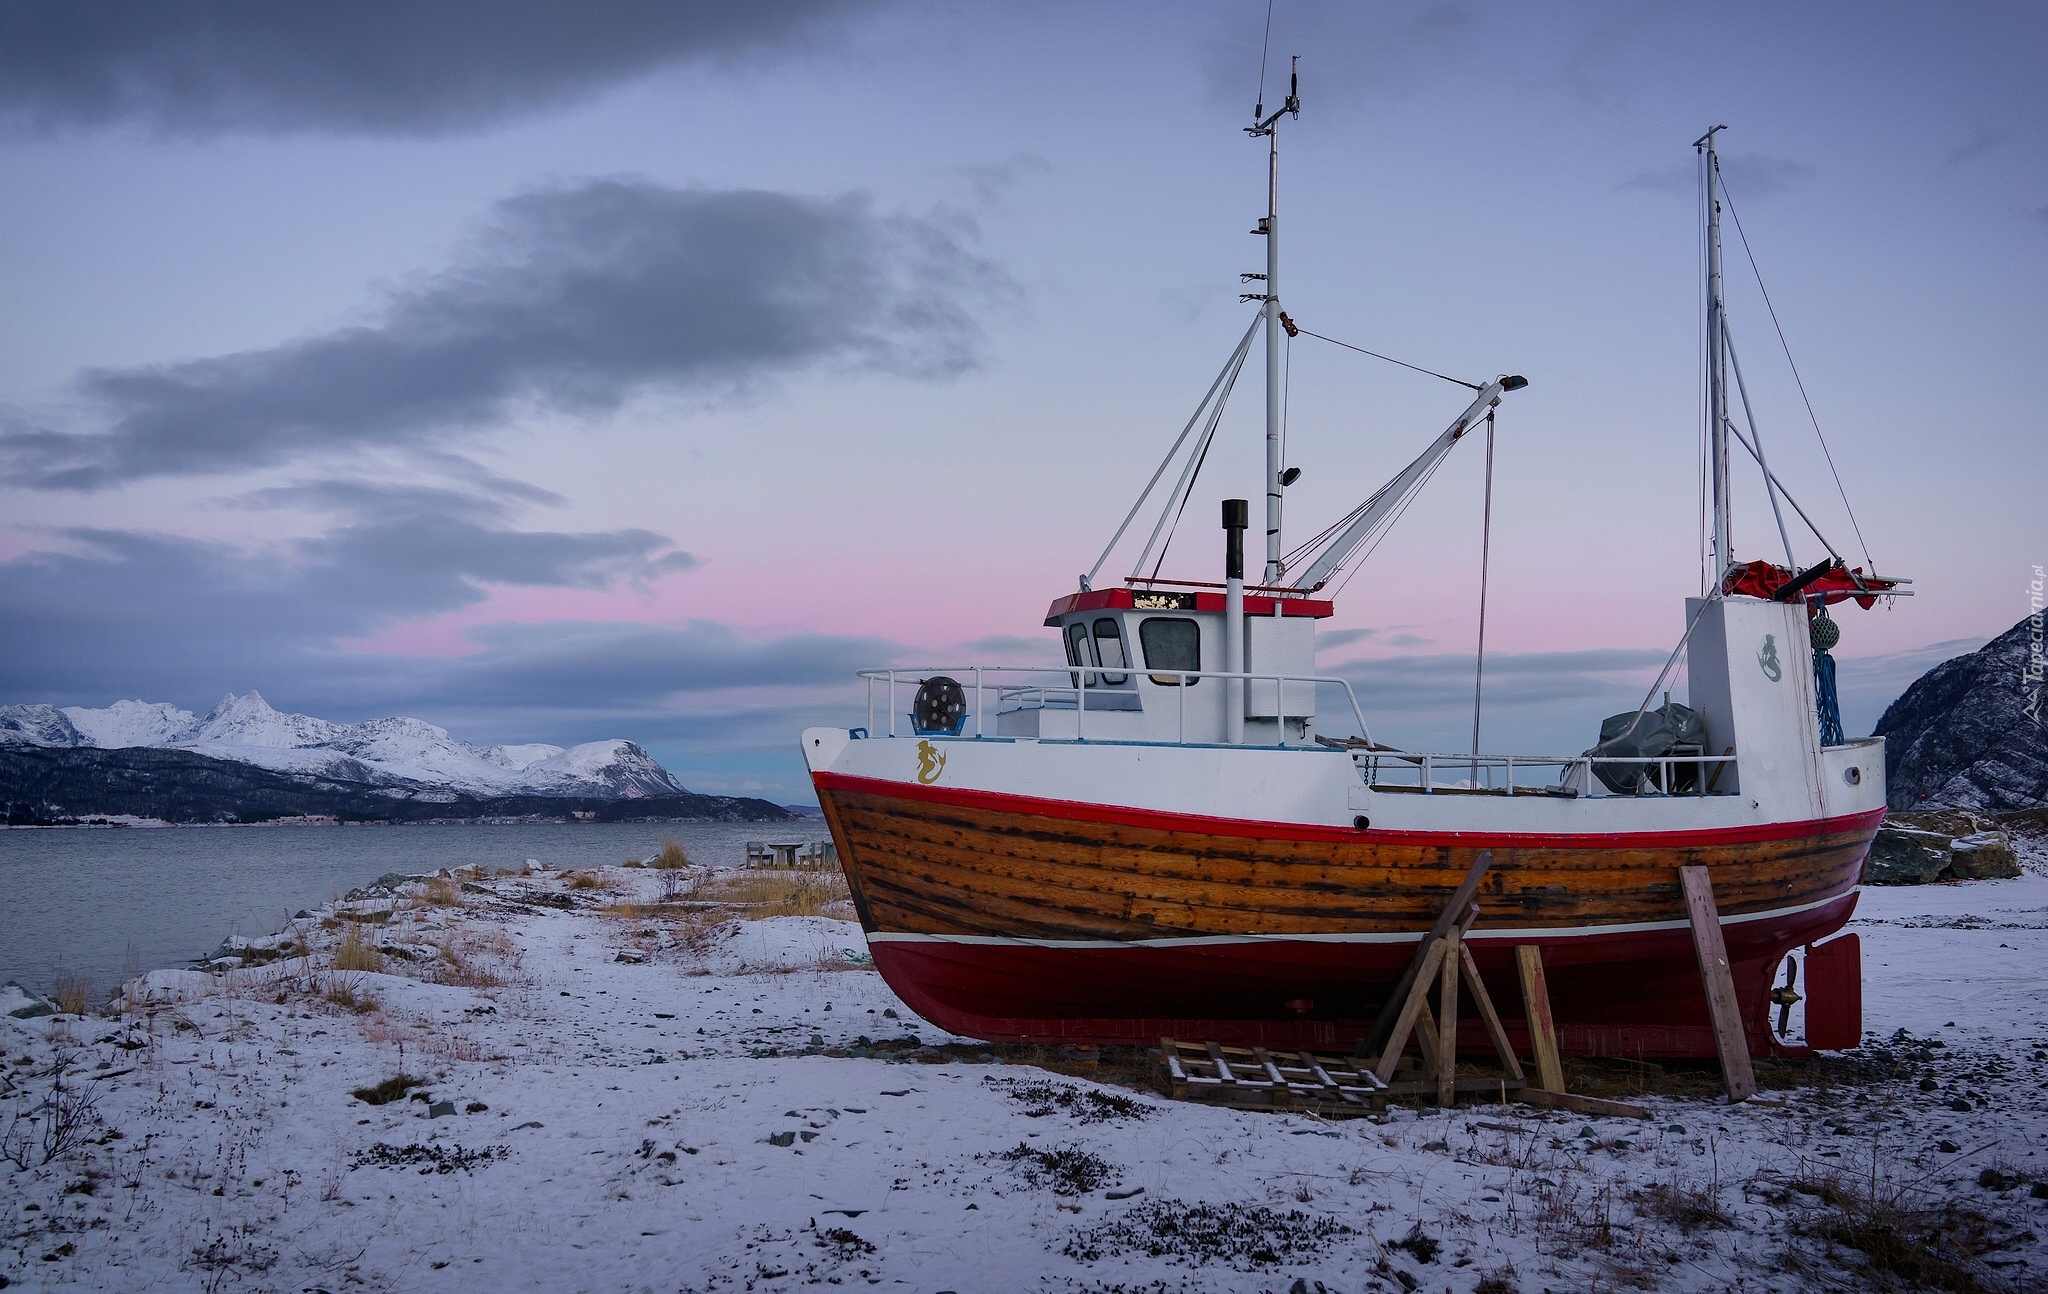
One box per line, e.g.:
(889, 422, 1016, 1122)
(0, 483, 696, 704)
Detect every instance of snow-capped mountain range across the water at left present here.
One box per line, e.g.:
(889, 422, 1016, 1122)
(0, 692, 684, 799)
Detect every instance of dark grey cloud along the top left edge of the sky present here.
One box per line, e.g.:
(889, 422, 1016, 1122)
(0, 0, 872, 135)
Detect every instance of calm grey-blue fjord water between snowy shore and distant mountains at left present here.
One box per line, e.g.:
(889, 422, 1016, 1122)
(0, 819, 827, 997)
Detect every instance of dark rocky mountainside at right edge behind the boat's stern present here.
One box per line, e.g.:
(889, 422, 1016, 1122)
(1876, 618, 2048, 813)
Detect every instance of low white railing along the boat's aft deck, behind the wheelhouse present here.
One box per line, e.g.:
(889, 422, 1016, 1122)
(1352, 749, 1737, 796)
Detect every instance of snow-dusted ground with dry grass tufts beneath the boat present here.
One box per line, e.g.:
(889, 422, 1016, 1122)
(0, 868, 2048, 1294)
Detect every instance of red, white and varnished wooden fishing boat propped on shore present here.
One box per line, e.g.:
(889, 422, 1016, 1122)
(803, 84, 1909, 1056)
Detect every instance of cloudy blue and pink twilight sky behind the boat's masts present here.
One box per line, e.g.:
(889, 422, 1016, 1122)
(0, 0, 2048, 801)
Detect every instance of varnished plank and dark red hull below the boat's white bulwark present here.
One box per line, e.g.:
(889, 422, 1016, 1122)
(815, 772, 1882, 1056)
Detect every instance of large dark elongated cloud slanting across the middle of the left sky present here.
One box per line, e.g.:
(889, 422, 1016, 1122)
(0, 180, 1006, 489)
